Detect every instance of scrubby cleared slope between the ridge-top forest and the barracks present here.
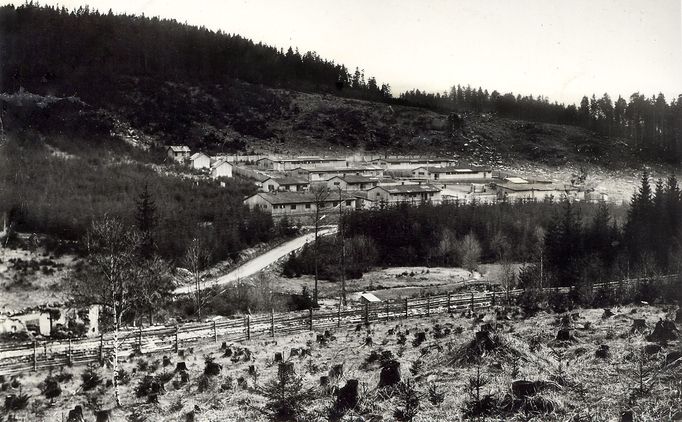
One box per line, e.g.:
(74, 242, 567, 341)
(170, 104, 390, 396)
(0, 77, 637, 168)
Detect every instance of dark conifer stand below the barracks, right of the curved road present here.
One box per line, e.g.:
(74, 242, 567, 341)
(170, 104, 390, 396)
(283, 173, 682, 287)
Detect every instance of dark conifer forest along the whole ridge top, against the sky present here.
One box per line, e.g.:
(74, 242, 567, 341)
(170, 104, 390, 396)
(0, 3, 682, 164)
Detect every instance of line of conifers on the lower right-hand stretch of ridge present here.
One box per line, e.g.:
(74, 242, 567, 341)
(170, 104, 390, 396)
(400, 85, 682, 164)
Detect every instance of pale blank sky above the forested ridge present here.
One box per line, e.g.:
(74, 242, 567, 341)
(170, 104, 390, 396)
(17, 0, 682, 103)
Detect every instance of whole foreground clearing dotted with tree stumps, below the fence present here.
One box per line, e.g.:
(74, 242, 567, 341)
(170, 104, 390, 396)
(2, 304, 682, 421)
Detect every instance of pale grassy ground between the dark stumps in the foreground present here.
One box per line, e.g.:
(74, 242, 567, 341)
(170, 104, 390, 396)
(6, 305, 682, 421)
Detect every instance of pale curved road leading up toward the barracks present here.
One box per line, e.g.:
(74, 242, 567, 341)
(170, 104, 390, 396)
(173, 227, 338, 295)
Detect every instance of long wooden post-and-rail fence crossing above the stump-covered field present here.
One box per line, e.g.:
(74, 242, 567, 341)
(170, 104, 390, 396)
(0, 275, 677, 375)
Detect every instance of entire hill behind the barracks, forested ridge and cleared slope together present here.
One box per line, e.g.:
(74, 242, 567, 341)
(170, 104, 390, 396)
(0, 3, 682, 165)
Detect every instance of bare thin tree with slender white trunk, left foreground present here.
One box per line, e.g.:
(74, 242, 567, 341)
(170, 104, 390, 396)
(72, 217, 140, 406)
